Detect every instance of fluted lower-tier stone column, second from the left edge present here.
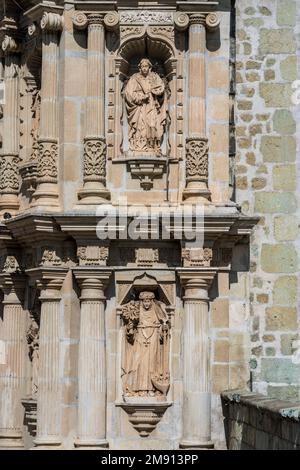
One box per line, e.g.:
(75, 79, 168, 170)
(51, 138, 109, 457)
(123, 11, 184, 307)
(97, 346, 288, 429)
(33, 268, 67, 449)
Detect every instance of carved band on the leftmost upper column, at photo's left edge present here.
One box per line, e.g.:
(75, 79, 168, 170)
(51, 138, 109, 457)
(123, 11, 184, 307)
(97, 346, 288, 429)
(0, 154, 20, 194)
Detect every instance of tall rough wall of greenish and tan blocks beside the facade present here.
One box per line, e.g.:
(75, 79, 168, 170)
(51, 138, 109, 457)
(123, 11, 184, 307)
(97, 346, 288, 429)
(235, 0, 300, 399)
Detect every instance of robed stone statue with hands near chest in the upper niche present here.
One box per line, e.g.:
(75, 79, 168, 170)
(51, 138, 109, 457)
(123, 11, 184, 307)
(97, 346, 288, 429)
(125, 59, 167, 155)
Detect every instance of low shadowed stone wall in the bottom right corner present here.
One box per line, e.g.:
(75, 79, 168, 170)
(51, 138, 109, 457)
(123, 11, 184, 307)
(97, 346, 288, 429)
(222, 391, 300, 450)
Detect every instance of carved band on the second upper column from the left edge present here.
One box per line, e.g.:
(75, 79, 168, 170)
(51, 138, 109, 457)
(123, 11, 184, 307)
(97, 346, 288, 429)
(37, 139, 58, 183)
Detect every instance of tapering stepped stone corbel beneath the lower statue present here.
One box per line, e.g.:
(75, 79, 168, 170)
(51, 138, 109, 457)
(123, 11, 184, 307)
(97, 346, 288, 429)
(116, 402, 172, 437)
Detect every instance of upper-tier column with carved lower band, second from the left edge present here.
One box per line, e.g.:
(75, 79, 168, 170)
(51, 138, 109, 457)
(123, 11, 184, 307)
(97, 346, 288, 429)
(34, 13, 63, 208)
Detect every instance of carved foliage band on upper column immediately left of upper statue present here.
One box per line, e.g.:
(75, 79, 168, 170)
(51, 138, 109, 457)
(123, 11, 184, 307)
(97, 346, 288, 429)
(83, 138, 106, 183)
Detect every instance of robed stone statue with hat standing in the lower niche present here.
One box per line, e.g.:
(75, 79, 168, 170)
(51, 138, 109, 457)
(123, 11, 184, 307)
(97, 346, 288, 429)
(121, 291, 170, 400)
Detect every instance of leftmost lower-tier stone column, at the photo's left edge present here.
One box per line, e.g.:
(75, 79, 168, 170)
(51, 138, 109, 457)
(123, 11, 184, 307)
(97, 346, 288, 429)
(0, 274, 26, 448)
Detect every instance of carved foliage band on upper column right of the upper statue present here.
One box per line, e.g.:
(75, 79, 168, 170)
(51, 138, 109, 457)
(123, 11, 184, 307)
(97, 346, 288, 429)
(186, 137, 208, 181)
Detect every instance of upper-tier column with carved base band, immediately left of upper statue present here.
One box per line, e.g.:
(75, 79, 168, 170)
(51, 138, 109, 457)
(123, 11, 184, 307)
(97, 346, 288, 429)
(73, 13, 110, 205)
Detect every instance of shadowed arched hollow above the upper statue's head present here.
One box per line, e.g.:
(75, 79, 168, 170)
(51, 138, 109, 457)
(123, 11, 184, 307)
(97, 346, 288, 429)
(118, 32, 177, 80)
